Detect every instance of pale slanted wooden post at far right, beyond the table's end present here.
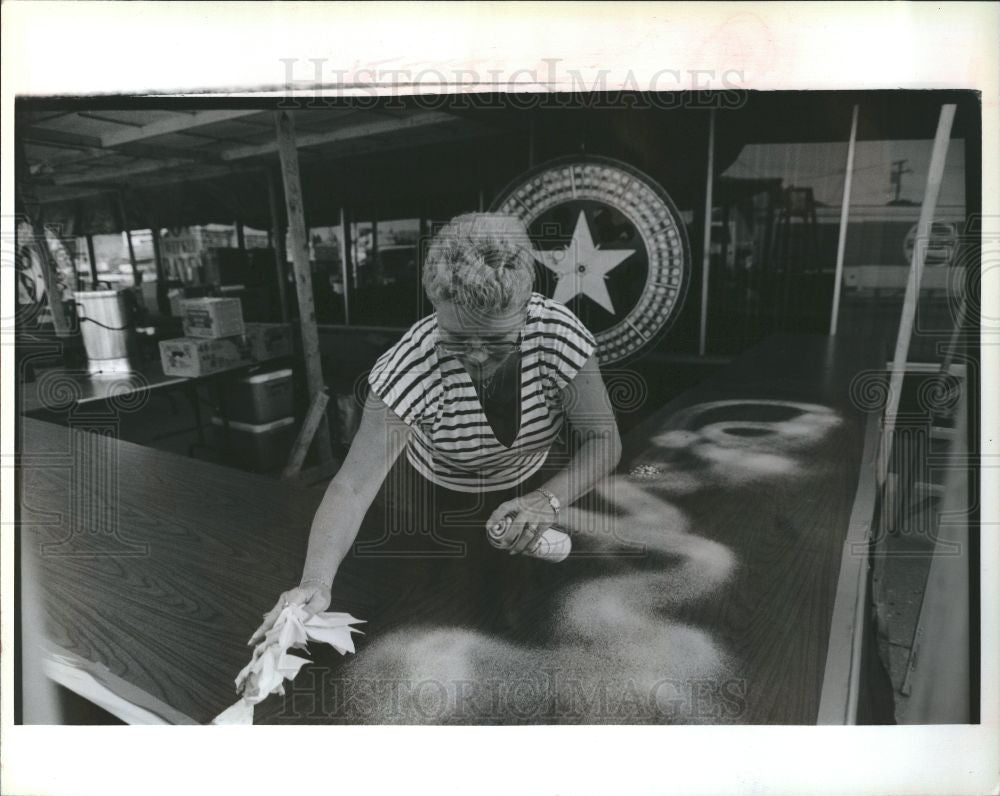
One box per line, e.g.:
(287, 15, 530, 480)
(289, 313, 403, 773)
(876, 105, 956, 487)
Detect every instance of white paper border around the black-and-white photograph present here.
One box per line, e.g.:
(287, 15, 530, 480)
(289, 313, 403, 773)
(0, 2, 1000, 796)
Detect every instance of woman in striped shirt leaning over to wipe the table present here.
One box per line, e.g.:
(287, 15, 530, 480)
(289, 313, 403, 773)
(250, 214, 621, 644)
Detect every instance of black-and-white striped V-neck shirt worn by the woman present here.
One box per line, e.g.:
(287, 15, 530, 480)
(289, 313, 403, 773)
(368, 293, 596, 492)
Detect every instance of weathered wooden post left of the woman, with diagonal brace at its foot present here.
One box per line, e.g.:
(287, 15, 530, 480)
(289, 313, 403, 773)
(274, 111, 332, 464)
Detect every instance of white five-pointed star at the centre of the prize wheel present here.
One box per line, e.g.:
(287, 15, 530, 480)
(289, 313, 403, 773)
(537, 210, 635, 315)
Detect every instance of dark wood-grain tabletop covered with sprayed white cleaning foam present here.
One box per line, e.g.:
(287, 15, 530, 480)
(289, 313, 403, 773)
(20, 337, 867, 724)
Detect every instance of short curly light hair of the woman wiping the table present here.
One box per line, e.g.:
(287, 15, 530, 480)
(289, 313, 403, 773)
(423, 213, 535, 312)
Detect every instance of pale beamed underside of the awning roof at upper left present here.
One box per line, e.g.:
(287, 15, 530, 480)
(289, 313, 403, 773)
(18, 107, 508, 204)
